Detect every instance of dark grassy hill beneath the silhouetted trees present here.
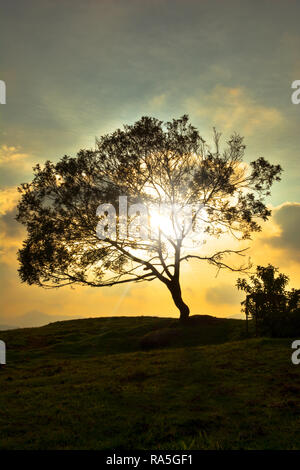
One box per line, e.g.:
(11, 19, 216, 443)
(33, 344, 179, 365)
(0, 317, 300, 450)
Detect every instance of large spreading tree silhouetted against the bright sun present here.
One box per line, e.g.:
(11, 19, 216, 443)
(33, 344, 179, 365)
(17, 116, 281, 320)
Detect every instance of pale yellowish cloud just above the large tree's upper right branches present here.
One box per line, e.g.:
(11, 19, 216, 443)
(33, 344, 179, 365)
(186, 85, 284, 136)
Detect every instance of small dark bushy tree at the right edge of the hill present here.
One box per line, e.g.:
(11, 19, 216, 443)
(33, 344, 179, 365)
(237, 264, 300, 336)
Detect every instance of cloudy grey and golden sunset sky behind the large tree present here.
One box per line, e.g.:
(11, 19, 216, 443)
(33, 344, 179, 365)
(0, 0, 300, 326)
